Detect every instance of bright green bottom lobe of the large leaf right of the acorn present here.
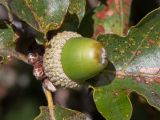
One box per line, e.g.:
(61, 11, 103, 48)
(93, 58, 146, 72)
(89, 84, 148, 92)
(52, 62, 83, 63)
(94, 85, 132, 120)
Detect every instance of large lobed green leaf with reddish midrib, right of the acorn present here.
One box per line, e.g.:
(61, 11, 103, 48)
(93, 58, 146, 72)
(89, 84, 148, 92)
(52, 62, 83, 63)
(94, 8, 160, 120)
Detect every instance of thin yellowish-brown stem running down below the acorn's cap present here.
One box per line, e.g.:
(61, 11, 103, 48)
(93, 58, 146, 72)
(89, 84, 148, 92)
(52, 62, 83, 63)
(43, 87, 56, 120)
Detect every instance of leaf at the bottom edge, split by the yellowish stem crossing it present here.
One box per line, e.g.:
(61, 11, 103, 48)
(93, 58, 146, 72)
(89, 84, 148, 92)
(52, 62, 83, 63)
(34, 105, 87, 120)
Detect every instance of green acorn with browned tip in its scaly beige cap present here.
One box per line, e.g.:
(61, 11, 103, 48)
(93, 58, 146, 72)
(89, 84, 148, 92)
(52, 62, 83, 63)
(43, 31, 108, 88)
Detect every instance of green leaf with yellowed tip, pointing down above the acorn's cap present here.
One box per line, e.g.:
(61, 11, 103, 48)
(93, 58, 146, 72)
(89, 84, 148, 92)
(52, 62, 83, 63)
(10, 0, 69, 33)
